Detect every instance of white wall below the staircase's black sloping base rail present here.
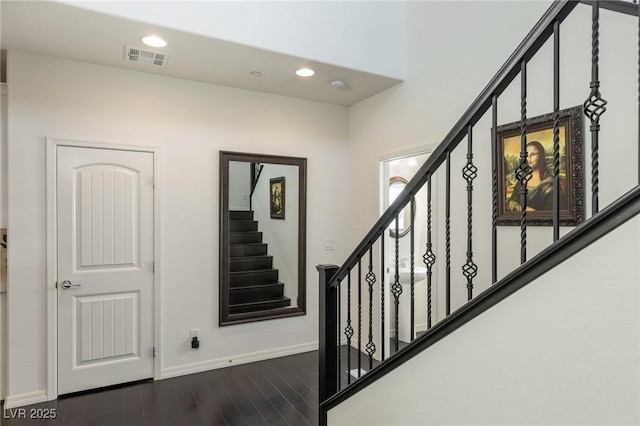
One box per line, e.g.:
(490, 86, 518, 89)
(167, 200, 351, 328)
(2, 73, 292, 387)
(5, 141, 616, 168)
(328, 217, 640, 426)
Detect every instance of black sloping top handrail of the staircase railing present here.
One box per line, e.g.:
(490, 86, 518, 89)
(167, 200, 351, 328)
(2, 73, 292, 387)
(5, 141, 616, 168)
(329, 0, 579, 287)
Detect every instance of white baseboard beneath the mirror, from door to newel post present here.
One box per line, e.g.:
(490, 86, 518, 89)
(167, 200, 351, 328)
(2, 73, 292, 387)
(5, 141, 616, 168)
(160, 342, 318, 379)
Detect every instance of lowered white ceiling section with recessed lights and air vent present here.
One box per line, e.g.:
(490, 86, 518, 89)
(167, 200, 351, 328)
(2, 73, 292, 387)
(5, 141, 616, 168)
(0, 0, 400, 106)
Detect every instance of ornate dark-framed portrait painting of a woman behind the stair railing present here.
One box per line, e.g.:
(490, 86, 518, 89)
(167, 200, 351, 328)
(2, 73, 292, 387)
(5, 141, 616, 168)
(496, 106, 584, 226)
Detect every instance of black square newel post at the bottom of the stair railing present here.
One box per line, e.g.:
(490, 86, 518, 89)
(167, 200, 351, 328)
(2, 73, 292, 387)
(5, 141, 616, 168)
(316, 265, 338, 411)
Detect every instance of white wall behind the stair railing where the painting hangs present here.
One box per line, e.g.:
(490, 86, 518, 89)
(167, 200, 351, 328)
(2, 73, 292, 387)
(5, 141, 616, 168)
(349, 1, 638, 330)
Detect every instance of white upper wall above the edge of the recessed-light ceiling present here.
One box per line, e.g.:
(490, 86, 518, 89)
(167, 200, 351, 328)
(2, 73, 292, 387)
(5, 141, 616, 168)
(64, 1, 406, 79)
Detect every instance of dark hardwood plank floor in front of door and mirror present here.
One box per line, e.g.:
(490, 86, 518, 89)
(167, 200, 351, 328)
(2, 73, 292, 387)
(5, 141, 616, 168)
(0, 351, 318, 426)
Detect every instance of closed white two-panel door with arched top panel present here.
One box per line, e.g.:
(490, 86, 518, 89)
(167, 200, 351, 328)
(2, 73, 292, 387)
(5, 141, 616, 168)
(56, 146, 154, 395)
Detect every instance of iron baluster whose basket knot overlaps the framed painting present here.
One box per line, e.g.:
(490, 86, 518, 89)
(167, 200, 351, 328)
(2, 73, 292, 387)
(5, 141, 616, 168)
(515, 60, 533, 263)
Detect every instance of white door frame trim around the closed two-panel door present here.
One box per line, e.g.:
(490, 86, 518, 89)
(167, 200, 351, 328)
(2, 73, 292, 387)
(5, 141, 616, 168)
(46, 137, 162, 400)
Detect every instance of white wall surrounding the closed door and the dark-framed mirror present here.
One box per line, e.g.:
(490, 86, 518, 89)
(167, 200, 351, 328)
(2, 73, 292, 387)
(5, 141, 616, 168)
(7, 51, 347, 398)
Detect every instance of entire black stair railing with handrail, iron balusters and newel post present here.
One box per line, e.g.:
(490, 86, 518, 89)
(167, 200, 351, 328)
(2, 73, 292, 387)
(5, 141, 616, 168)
(319, 0, 640, 424)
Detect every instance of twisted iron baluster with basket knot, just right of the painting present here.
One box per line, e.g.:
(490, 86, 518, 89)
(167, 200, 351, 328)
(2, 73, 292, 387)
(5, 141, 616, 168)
(583, 0, 607, 214)
